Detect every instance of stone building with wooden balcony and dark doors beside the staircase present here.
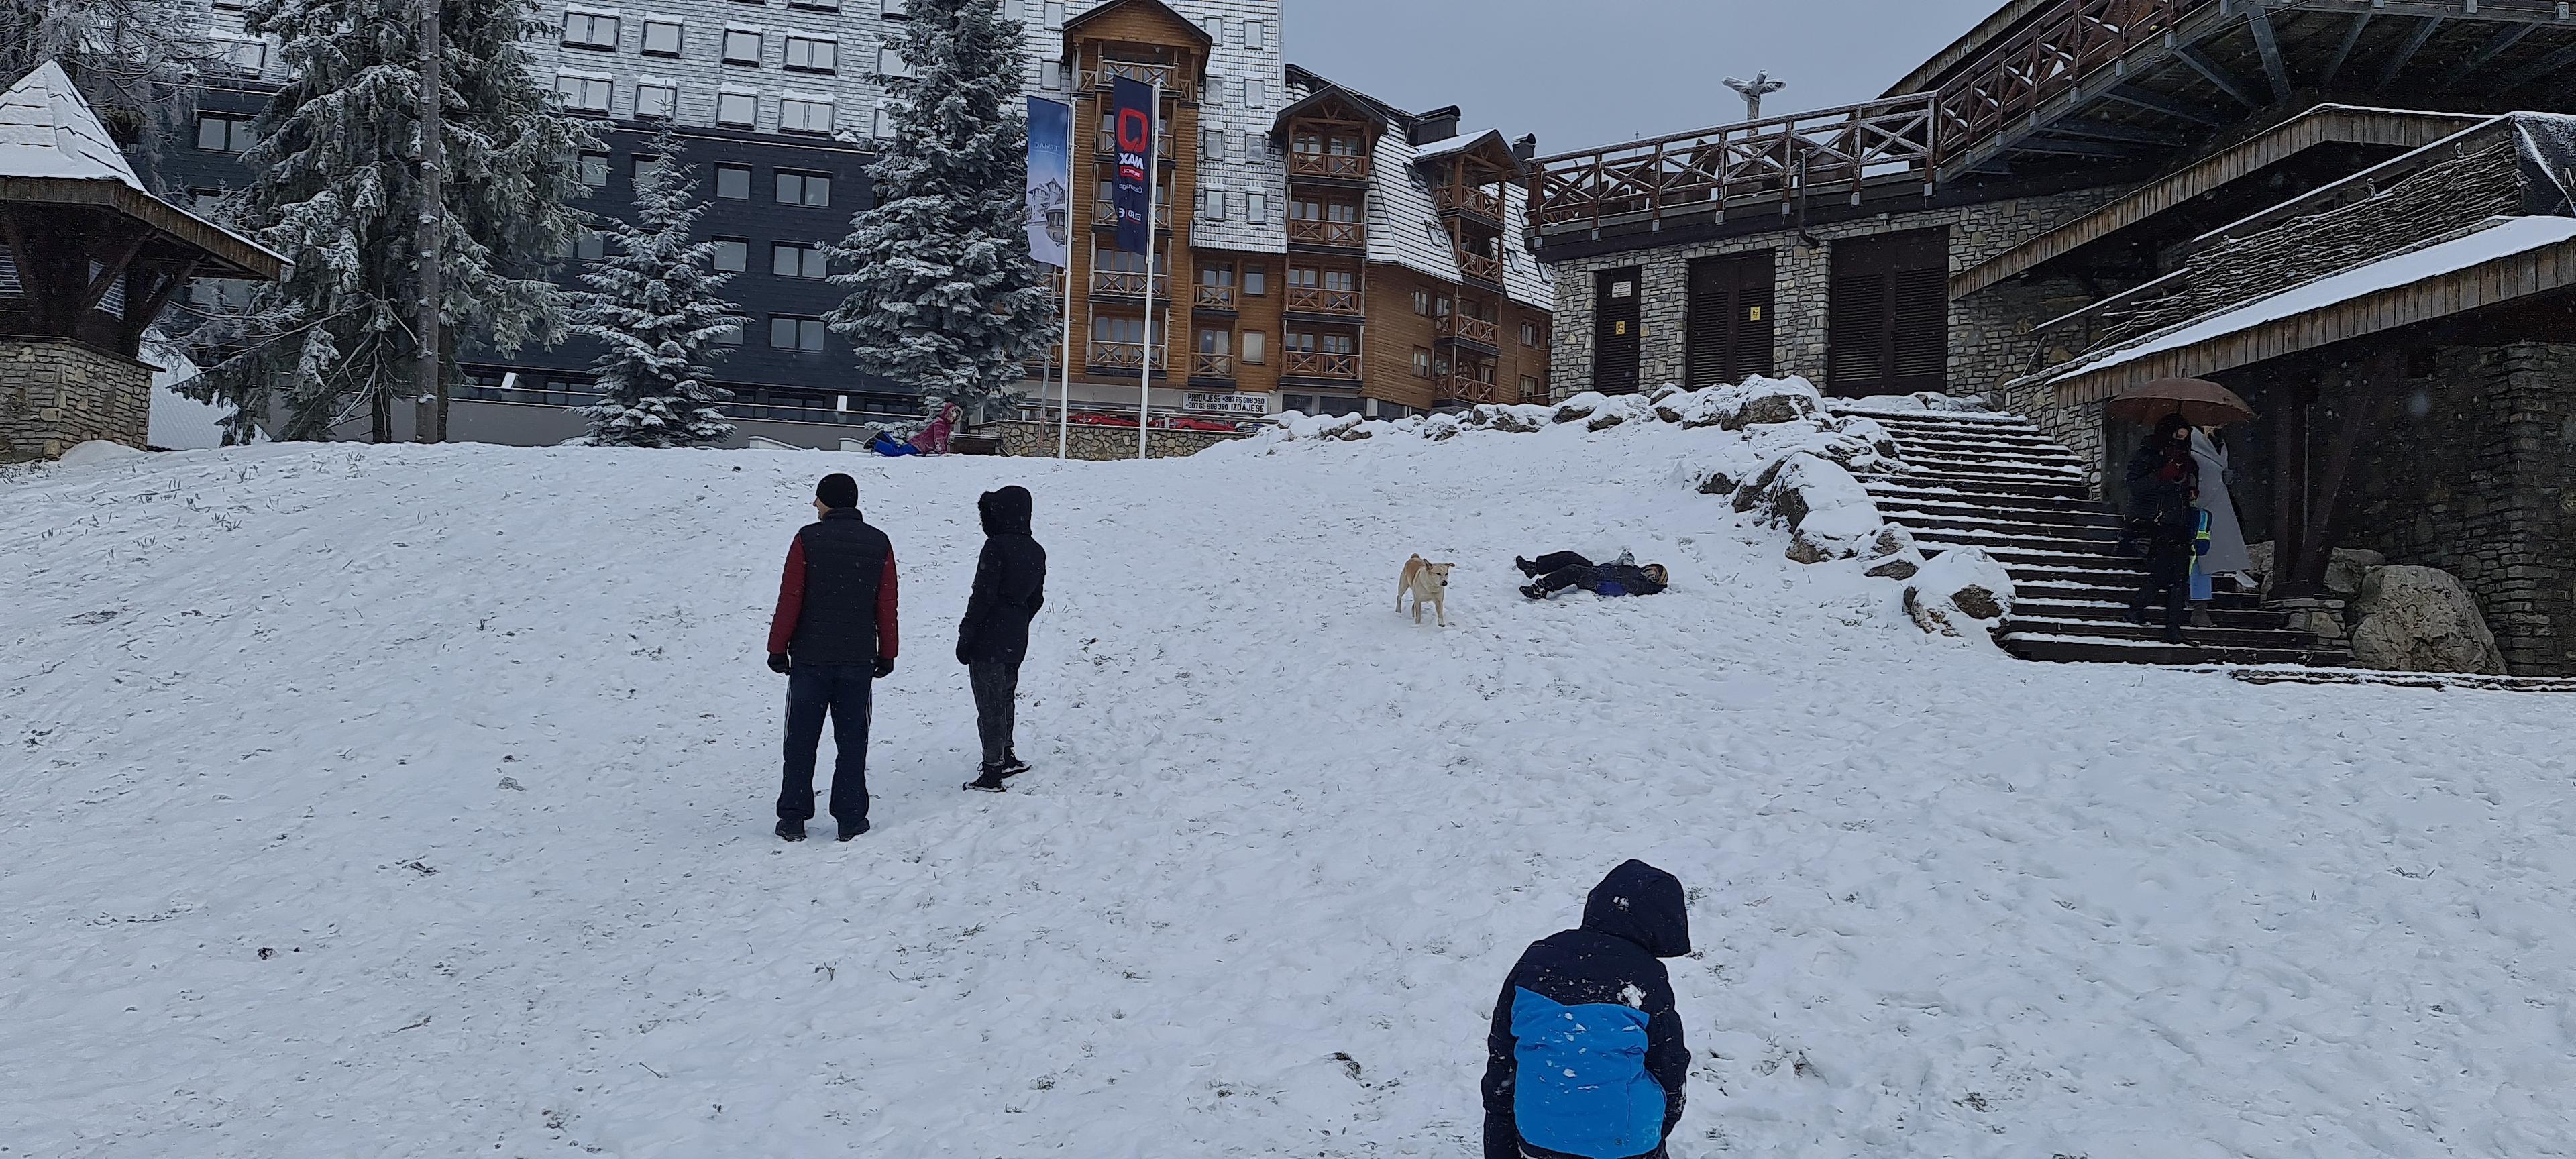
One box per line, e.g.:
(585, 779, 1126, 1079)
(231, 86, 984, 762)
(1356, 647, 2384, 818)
(1533, 0, 2576, 675)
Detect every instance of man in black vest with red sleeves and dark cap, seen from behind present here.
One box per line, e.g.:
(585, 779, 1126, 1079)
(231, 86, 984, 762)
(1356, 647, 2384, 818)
(770, 474, 896, 842)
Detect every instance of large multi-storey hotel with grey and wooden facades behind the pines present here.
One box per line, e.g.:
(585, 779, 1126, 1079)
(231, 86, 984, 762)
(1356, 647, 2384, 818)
(165, 0, 1551, 445)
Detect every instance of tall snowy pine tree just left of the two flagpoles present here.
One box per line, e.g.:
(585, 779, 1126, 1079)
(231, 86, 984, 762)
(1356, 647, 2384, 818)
(829, 0, 1056, 412)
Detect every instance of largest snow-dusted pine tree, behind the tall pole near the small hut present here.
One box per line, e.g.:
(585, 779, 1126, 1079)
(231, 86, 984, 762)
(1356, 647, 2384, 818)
(191, 0, 598, 441)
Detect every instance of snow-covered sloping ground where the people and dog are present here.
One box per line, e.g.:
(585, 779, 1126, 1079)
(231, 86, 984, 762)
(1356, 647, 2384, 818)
(0, 423, 2576, 1159)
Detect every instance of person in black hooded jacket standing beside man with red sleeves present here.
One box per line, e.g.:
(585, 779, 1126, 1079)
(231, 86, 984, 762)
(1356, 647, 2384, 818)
(958, 487, 1046, 793)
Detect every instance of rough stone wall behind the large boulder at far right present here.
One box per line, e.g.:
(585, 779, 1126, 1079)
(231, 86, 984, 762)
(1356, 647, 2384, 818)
(2316, 343, 2576, 675)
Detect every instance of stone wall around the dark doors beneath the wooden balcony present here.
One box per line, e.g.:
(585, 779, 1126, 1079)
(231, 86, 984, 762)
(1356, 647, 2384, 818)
(1548, 188, 2123, 399)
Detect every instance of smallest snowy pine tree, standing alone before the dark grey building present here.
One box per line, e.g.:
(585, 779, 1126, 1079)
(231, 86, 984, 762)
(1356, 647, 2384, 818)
(572, 123, 749, 445)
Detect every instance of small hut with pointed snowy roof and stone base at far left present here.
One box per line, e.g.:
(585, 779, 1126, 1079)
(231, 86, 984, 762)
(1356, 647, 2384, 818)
(0, 64, 283, 461)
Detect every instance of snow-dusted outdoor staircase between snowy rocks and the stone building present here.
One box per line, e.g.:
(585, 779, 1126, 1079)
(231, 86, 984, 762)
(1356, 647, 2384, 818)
(1837, 407, 2349, 665)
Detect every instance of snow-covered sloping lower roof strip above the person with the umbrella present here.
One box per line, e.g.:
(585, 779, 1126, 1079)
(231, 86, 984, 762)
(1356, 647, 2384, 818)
(2037, 217, 2576, 384)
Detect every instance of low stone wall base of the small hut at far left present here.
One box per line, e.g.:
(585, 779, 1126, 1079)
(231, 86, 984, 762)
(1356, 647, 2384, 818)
(0, 337, 152, 459)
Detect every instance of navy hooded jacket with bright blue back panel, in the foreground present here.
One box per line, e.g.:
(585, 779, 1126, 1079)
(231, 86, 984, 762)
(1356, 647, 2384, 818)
(1484, 861, 1690, 1159)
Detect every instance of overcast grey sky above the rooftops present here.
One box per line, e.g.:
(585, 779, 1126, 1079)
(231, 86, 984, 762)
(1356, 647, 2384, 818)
(1283, 0, 2004, 152)
